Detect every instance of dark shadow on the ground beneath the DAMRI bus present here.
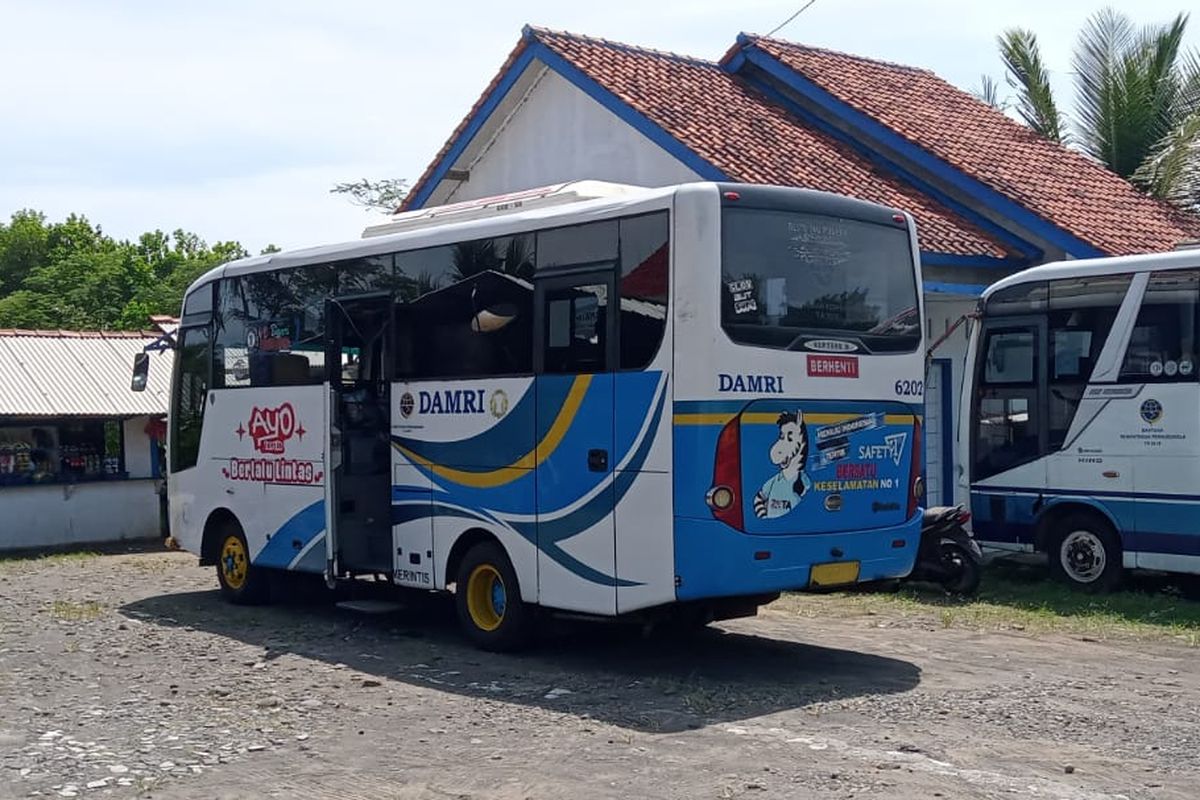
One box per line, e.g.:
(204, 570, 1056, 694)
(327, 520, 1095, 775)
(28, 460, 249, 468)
(120, 591, 920, 732)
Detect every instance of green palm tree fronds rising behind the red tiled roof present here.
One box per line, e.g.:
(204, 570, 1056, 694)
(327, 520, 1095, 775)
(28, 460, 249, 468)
(997, 8, 1200, 206)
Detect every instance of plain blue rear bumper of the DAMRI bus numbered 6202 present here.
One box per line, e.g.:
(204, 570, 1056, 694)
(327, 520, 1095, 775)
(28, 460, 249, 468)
(674, 513, 920, 600)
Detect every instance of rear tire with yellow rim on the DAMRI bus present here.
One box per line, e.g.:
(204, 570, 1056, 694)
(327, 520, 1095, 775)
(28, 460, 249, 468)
(455, 542, 533, 652)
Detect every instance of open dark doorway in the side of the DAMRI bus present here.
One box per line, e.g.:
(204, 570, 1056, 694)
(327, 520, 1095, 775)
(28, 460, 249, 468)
(325, 294, 394, 582)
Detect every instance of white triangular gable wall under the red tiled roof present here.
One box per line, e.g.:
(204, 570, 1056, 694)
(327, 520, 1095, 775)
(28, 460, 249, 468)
(446, 66, 700, 201)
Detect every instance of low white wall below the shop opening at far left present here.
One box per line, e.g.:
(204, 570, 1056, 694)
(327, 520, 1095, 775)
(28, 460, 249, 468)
(0, 481, 158, 551)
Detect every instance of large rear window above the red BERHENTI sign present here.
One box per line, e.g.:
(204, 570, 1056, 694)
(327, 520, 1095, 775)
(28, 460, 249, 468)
(721, 207, 920, 353)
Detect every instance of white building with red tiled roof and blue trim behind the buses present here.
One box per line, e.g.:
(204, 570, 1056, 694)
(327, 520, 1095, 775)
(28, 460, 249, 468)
(403, 26, 1200, 500)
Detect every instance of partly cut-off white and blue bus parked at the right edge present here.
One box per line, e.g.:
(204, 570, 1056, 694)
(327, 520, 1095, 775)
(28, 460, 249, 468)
(959, 249, 1200, 590)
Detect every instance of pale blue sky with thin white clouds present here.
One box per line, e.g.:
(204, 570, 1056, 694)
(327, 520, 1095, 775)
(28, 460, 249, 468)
(0, 0, 1200, 252)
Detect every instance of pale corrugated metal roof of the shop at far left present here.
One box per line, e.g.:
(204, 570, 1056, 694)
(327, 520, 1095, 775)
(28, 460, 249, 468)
(0, 330, 174, 416)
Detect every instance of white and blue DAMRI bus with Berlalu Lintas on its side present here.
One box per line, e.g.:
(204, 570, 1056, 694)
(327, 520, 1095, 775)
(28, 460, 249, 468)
(150, 182, 924, 649)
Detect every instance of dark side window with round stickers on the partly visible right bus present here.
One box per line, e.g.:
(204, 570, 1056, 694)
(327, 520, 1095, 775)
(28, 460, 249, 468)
(1121, 270, 1200, 383)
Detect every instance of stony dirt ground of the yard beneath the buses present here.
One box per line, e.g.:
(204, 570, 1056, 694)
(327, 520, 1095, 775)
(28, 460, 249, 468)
(0, 553, 1200, 800)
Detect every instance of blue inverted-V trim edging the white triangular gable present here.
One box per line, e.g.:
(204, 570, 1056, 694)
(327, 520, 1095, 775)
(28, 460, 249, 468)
(407, 34, 730, 210)
